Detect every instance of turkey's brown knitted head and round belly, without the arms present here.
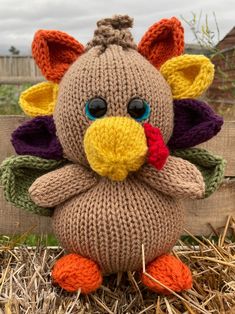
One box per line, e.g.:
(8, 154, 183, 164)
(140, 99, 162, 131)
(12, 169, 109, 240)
(53, 25, 198, 273)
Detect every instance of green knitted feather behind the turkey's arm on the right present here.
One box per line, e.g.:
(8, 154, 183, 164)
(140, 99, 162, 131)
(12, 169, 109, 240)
(171, 148, 226, 198)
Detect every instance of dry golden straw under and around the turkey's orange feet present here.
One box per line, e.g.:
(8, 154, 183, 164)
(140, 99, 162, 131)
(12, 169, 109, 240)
(0, 217, 235, 314)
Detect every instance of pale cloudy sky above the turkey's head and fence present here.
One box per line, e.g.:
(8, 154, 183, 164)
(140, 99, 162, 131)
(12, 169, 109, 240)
(0, 0, 235, 55)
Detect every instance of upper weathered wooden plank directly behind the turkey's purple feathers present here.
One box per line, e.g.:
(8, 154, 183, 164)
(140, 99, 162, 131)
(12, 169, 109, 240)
(0, 116, 235, 177)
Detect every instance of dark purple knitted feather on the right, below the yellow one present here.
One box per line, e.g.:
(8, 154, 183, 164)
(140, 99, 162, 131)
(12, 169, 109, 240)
(168, 99, 223, 149)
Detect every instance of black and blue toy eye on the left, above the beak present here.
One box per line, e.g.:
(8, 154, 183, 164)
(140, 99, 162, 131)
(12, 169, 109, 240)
(85, 97, 107, 120)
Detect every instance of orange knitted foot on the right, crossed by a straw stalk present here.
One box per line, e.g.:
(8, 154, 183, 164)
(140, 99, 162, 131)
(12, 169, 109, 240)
(141, 255, 192, 294)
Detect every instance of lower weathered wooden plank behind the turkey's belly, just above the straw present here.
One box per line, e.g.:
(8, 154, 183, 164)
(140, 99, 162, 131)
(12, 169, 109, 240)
(0, 179, 235, 235)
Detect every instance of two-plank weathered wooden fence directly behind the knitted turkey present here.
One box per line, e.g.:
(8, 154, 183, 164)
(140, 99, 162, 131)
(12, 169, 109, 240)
(0, 116, 235, 235)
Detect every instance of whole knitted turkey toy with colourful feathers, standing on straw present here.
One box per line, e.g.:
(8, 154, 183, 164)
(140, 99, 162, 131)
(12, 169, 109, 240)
(1, 15, 224, 294)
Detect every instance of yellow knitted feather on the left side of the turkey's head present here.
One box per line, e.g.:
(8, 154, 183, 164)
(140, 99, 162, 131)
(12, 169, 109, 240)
(19, 82, 58, 117)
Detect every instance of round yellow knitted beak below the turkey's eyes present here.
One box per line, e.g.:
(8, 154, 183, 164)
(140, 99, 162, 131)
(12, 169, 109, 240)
(84, 117, 148, 181)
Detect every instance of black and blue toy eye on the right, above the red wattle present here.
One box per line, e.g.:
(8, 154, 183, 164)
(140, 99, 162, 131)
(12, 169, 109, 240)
(127, 98, 151, 121)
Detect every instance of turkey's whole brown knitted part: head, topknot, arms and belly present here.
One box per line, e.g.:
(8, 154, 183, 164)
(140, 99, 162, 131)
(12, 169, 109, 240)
(30, 16, 207, 274)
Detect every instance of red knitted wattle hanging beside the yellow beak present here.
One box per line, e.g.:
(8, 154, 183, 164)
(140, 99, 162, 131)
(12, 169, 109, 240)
(144, 123, 169, 170)
